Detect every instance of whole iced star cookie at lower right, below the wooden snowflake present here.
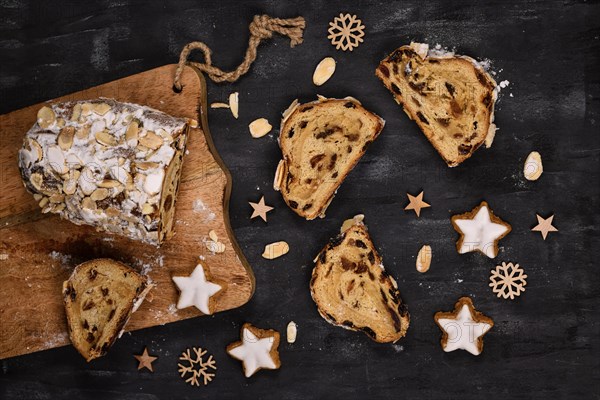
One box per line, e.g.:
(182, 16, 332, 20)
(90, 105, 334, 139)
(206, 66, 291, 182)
(434, 297, 494, 356)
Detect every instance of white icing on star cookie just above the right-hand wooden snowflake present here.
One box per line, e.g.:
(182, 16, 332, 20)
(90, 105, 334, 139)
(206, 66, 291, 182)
(454, 206, 508, 258)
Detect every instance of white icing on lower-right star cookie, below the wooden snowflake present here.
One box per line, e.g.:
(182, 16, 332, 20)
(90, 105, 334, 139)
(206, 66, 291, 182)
(438, 304, 491, 356)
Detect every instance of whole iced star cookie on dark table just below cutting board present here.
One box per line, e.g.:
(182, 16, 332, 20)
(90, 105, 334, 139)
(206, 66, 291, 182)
(227, 323, 281, 378)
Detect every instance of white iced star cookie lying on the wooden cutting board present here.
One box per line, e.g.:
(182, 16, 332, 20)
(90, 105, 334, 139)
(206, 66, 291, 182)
(173, 264, 224, 314)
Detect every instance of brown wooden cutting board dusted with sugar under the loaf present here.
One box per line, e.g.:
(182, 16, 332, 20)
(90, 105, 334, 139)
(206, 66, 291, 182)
(0, 65, 254, 359)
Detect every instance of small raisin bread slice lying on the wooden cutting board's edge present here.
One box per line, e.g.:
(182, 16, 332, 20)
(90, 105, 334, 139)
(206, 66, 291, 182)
(63, 259, 153, 361)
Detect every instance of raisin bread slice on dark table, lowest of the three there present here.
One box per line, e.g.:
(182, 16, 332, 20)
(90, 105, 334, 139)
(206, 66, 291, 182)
(310, 219, 410, 343)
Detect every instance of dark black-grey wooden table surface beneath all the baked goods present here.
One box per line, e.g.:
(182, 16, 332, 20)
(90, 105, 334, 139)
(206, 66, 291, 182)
(0, 0, 600, 399)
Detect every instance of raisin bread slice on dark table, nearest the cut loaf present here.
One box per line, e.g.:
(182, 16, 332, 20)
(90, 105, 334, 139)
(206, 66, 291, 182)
(273, 96, 385, 220)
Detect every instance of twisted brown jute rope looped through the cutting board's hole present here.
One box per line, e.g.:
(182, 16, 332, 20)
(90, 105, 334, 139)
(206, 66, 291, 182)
(173, 15, 305, 90)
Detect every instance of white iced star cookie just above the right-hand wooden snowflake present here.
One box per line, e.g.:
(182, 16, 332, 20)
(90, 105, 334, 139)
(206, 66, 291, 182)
(452, 201, 512, 258)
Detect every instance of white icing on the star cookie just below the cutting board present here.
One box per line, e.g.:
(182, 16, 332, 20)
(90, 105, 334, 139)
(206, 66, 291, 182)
(228, 328, 277, 378)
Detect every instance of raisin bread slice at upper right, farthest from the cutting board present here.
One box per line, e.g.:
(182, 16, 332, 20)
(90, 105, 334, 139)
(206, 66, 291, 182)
(376, 43, 498, 167)
